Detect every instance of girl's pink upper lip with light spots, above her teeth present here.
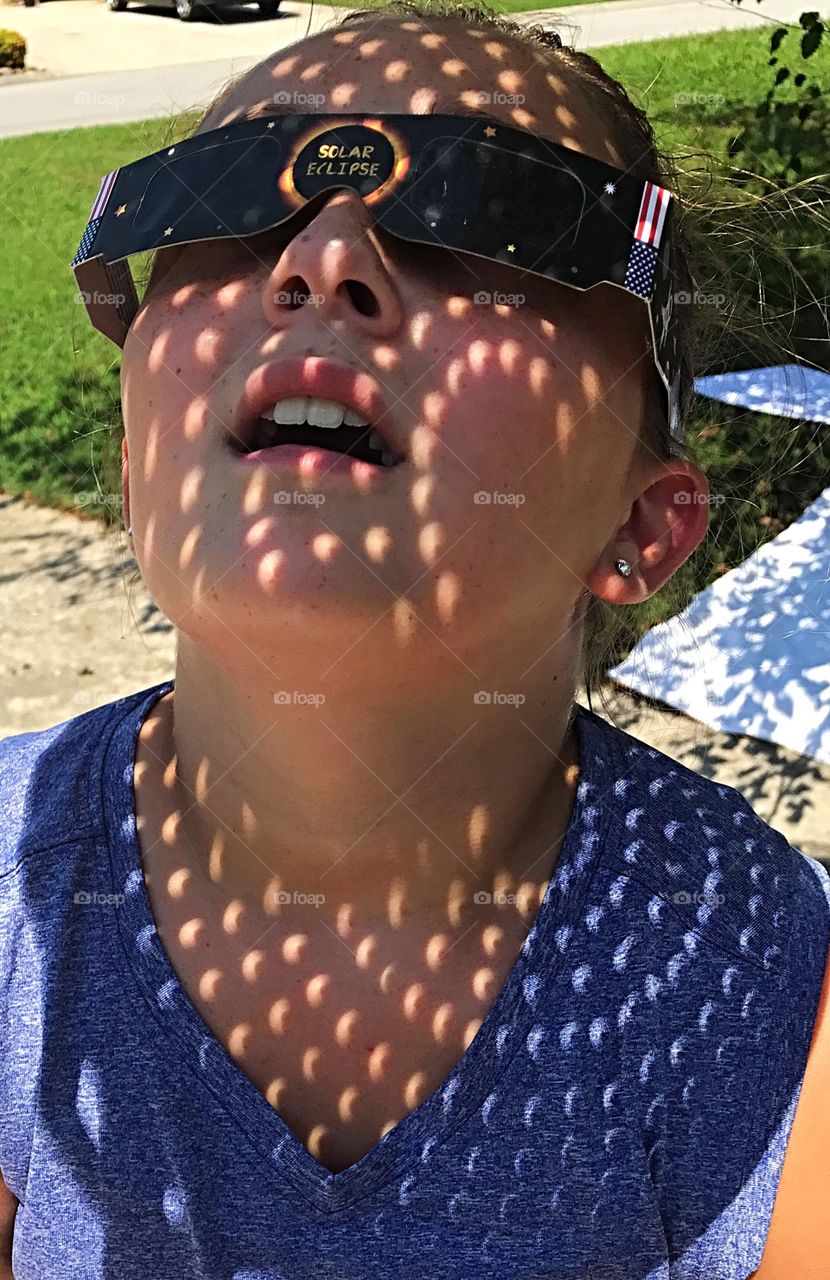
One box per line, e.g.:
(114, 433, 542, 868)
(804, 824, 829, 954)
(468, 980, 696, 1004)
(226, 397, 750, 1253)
(229, 356, 406, 458)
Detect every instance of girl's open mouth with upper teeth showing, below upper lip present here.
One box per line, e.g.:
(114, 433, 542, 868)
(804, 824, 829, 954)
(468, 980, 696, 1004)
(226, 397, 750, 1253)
(231, 396, 403, 467)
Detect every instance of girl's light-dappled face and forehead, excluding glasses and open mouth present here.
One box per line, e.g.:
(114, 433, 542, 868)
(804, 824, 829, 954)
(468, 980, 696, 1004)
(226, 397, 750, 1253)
(122, 19, 653, 678)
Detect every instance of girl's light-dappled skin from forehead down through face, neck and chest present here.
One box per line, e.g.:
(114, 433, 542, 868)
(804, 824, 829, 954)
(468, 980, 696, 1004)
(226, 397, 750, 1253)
(122, 20, 712, 1171)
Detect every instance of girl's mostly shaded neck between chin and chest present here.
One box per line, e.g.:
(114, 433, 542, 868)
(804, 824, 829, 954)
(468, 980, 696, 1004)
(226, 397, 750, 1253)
(139, 636, 579, 922)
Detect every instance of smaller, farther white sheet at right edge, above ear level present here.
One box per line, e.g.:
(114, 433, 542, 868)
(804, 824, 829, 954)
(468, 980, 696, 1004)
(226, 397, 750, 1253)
(694, 365, 830, 424)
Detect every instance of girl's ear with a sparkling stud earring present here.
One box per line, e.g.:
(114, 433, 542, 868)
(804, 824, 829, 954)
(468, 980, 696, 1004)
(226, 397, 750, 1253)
(587, 460, 711, 604)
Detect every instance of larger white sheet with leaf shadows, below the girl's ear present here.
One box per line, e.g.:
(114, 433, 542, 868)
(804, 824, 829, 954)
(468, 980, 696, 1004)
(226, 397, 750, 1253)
(610, 483, 830, 764)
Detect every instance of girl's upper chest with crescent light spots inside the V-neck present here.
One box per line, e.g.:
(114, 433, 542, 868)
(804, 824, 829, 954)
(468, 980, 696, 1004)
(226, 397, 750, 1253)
(140, 877, 526, 1172)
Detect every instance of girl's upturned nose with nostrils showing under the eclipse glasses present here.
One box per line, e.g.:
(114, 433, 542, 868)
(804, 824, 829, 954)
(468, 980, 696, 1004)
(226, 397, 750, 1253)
(263, 191, 402, 338)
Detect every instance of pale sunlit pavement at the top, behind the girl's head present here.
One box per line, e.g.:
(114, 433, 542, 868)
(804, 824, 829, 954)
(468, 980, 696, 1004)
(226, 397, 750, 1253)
(0, 0, 830, 137)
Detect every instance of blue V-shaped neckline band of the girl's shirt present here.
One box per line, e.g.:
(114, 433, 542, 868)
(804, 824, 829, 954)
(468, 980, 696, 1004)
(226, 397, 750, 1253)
(100, 680, 610, 1216)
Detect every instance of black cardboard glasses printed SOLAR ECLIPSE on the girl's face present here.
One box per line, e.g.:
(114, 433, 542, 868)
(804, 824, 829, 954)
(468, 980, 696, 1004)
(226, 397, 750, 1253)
(72, 114, 683, 443)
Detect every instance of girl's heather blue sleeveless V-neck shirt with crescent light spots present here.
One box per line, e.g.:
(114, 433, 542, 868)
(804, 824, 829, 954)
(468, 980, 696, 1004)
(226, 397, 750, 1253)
(0, 681, 830, 1280)
